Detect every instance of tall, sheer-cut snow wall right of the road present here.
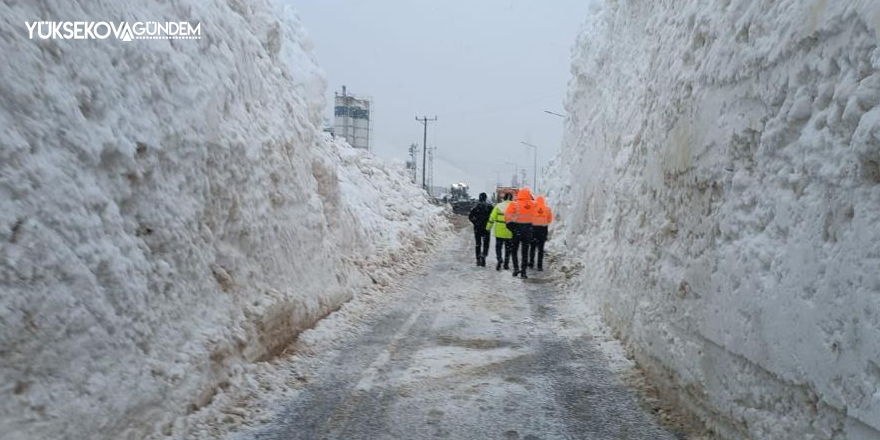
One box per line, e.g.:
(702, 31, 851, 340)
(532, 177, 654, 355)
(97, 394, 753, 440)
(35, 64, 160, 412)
(550, 0, 880, 439)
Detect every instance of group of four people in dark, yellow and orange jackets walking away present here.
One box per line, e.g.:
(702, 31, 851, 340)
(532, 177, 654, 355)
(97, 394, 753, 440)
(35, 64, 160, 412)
(468, 188, 553, 279)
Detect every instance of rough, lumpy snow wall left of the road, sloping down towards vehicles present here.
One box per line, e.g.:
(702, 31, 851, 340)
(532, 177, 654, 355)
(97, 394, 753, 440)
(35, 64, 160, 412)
(0, 0, 446, 440)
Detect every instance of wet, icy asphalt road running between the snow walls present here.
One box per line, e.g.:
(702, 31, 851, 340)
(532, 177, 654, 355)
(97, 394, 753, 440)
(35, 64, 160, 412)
(237, 228, 676, 440)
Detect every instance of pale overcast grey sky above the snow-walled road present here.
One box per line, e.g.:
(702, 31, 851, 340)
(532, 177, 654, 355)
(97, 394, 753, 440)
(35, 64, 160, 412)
(289, 0, 586, 195)
